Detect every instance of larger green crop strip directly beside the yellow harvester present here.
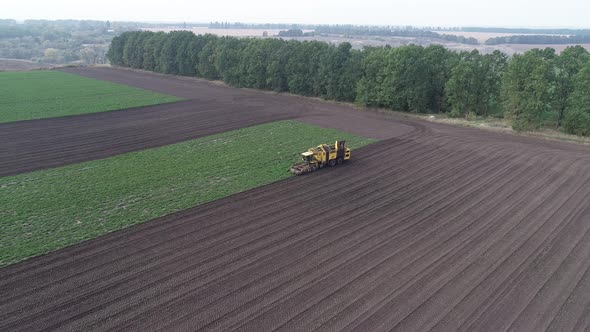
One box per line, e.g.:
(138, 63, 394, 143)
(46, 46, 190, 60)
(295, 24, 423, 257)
(0, 121, 374, 266)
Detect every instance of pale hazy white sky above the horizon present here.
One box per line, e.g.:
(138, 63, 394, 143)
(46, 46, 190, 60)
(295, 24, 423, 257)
(0, 0, 590, 28)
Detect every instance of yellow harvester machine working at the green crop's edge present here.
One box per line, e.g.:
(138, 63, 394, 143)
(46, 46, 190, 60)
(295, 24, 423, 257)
(289, 141, 350, 175)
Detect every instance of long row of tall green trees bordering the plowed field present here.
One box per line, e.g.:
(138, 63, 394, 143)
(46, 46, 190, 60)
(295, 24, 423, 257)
(107, 31, 590, 135)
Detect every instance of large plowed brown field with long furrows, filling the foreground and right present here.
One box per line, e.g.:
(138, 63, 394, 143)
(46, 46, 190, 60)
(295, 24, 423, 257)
(0, 69, 590, 331)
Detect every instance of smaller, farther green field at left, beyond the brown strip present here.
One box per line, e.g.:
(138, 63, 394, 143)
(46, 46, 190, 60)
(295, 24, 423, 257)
(0, 71, 181, 123)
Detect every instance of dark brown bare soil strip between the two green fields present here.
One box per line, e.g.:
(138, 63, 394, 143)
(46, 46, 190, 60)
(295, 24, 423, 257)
(0, 101, 297, 176)
